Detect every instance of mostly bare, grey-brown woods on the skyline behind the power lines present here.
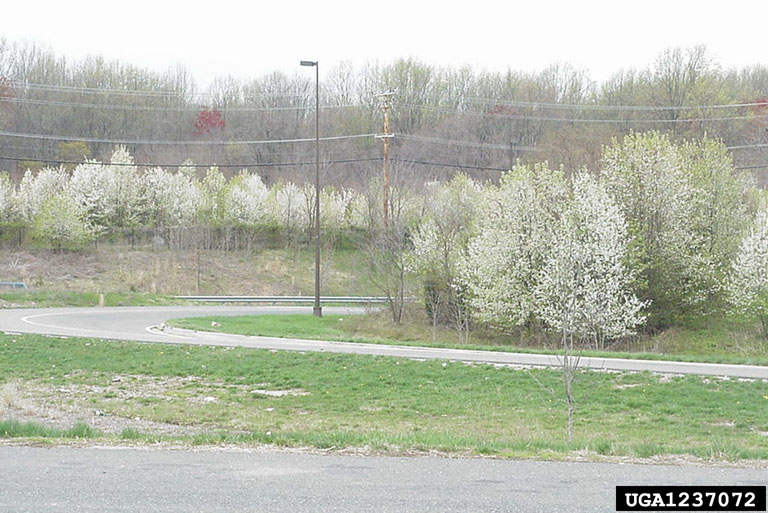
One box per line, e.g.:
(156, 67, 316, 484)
(0, 41, 768, 187)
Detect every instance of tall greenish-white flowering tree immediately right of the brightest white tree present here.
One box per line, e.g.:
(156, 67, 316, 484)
(602, 132, 713, 326)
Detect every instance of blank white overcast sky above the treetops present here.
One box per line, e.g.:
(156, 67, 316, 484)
(0, 0, 768, 87)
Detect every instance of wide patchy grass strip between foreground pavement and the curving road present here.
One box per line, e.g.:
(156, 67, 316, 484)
(0, 335, 768, 459)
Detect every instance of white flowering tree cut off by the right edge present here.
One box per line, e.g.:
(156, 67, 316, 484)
(728, 209, 768, 339)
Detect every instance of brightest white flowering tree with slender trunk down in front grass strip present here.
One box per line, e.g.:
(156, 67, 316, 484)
(534, 172, 646, 441)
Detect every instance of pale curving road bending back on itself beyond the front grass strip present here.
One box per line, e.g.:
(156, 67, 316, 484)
(0, 306, 768, 379)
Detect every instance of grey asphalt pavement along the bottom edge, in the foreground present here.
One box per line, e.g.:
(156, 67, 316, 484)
(0, 447, 768, 513)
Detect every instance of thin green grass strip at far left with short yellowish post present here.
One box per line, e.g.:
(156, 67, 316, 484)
(0, 290, 186, 308)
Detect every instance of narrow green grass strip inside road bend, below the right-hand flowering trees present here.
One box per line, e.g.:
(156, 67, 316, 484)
(168, 313, 768, 365)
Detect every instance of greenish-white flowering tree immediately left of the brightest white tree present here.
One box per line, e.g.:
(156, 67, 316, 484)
(461, 164, 568, 329)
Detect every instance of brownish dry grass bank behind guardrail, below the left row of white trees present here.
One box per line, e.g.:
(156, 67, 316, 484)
(0, 243, 377, 296)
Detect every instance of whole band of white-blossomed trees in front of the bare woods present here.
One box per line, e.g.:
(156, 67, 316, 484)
(0, 132, 768, 349)
